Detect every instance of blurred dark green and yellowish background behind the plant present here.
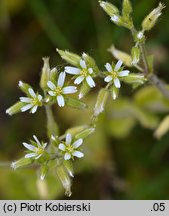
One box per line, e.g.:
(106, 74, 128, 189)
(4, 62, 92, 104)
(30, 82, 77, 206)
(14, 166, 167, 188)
(0, 0, 169, 199)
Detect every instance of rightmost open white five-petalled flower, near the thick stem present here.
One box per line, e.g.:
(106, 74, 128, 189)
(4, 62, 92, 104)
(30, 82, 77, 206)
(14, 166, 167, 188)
(104, 60, 130, 88)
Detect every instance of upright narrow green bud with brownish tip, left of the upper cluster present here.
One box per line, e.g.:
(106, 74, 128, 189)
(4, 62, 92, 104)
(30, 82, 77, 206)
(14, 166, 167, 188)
(40, 57, 50, 90)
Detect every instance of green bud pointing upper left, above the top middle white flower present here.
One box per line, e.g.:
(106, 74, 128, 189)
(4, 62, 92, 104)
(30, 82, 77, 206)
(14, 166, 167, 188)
(56, 49, 81, 67)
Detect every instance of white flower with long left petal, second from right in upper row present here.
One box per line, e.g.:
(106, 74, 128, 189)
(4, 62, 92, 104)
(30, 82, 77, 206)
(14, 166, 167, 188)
(65, 59, 95, 88)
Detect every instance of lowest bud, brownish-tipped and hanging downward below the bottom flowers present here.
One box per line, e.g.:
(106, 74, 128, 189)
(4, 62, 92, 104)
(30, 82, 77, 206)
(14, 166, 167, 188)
(56, 165, 72, 197)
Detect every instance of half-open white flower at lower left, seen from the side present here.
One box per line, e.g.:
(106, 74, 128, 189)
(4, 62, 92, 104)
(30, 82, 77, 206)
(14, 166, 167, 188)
(22, 135, 47, 159)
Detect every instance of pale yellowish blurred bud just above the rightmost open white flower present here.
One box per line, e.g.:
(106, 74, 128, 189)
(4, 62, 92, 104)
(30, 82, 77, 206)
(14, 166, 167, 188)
(108, 45, 132, 67)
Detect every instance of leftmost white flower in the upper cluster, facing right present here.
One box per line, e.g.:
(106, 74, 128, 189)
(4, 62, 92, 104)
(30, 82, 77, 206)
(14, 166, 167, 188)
(20, 88, 42, 113)
